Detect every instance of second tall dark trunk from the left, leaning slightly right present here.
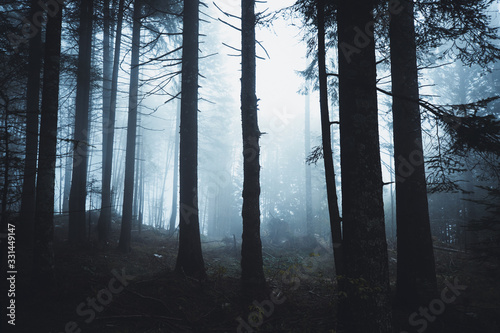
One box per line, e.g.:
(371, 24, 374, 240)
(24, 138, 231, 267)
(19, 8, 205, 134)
(33, 1, 62, 289)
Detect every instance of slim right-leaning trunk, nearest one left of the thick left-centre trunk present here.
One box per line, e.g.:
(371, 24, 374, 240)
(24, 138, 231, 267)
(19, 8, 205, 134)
(118, 0, 142, 252)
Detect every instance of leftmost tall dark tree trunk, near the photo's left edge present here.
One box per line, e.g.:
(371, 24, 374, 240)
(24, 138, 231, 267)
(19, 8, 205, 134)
(19, 0, 43, 265)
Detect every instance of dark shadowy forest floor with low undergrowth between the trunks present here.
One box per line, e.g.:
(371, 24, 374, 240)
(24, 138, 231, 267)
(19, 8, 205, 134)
(13, 214, 500, 333)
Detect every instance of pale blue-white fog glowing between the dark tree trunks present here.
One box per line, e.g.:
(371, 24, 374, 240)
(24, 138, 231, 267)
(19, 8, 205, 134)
(44, 0, 498, 248)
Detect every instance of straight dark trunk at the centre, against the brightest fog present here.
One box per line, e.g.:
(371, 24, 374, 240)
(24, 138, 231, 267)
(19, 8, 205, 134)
(241, 0, 266, 291)
